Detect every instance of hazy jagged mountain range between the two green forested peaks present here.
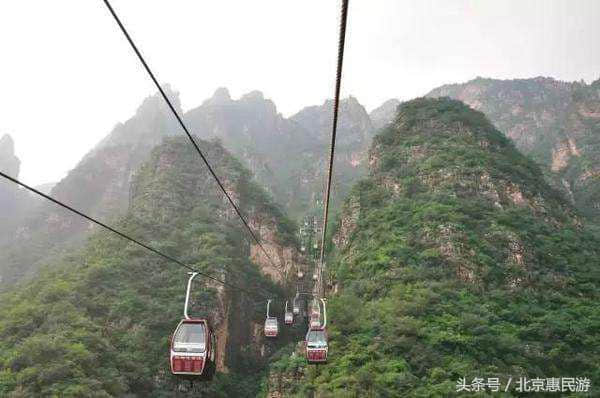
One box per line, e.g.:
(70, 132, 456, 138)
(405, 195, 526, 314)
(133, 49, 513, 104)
(185, 88, 374, 218)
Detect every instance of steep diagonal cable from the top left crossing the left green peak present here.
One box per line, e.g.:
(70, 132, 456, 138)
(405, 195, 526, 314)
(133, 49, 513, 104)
(103, 0, 275, 266)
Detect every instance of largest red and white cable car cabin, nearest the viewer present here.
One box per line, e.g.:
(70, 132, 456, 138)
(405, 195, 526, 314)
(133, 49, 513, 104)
(170, 319, 217, 379)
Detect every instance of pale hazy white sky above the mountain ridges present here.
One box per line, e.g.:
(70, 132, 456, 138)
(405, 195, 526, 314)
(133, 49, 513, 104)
(0, 0, 600, 184)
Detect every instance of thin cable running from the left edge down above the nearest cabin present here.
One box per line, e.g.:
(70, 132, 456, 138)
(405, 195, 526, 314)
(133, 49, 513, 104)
(0, 171, 276, 296)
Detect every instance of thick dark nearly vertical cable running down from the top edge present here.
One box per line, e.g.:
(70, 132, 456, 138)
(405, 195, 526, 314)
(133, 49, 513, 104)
(319, 0, 349, 294)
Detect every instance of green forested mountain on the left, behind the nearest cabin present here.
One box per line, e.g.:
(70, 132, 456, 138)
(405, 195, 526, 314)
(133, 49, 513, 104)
(0, 137, 307, 398)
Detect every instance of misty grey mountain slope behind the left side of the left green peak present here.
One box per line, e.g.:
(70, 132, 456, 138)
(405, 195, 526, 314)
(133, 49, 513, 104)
(0, 86, 179, 290)
